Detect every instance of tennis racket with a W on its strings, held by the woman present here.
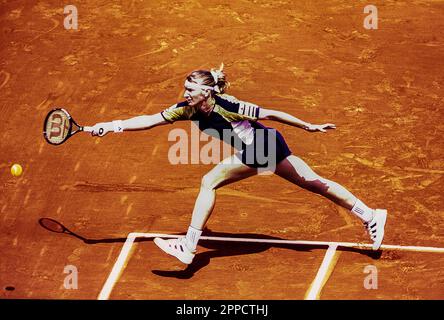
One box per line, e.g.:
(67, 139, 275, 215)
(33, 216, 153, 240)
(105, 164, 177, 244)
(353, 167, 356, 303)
(43, 108, 103, 145)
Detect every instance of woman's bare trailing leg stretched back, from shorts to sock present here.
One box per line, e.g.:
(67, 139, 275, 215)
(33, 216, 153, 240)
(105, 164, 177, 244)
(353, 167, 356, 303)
(275, 155, 357, 210)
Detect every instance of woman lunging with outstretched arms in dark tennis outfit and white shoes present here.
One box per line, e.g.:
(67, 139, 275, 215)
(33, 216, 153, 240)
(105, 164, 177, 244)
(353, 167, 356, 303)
(92, 65, 387, 264)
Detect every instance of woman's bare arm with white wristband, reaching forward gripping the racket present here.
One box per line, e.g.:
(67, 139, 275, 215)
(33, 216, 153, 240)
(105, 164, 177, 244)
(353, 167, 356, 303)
(91, 113, 169, 137)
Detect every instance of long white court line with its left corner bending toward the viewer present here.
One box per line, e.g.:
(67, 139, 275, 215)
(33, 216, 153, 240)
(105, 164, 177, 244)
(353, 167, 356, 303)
(98, 232, 444, 300)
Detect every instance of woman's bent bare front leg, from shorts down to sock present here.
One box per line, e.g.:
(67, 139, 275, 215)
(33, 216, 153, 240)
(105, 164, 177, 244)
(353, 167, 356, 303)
(191, 155, 257, 230)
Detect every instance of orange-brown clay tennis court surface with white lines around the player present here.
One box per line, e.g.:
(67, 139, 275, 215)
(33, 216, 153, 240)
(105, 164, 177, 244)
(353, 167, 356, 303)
(0, 0, 444, 300)
